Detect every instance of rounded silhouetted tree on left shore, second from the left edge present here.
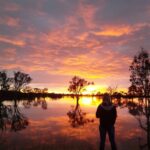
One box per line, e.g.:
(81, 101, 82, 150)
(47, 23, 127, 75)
(14, 71, 32, 91)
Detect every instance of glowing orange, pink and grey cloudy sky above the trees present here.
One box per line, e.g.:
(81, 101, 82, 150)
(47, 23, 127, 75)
(0, 0, 150, 92)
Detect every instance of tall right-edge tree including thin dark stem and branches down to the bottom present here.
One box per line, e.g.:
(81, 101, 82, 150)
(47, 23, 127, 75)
(129, 48, 150, 149)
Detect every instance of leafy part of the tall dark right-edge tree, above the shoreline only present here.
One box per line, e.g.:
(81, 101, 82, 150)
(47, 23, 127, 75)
(129, 48, 150, 96)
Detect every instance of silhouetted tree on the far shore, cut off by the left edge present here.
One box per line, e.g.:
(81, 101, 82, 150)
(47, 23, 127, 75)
(0, 71, 12, 91)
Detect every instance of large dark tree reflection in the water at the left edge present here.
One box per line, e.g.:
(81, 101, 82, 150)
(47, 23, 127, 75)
(0, 100, 28, 131)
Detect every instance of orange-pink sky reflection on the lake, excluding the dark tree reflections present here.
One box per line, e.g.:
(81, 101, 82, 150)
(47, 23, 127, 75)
(0, 98, 146, 150)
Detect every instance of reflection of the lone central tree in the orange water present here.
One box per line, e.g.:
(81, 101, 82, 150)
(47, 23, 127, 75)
(67, 99, 94, 128)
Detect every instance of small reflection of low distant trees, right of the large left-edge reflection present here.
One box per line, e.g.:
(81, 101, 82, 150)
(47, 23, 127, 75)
(23, 98, 47, 109)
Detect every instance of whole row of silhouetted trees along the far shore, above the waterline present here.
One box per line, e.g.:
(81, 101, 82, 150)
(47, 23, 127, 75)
(0, 48, 150, 97)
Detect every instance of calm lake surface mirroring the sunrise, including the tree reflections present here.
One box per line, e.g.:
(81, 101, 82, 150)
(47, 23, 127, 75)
(0, 97, 147, 150)
